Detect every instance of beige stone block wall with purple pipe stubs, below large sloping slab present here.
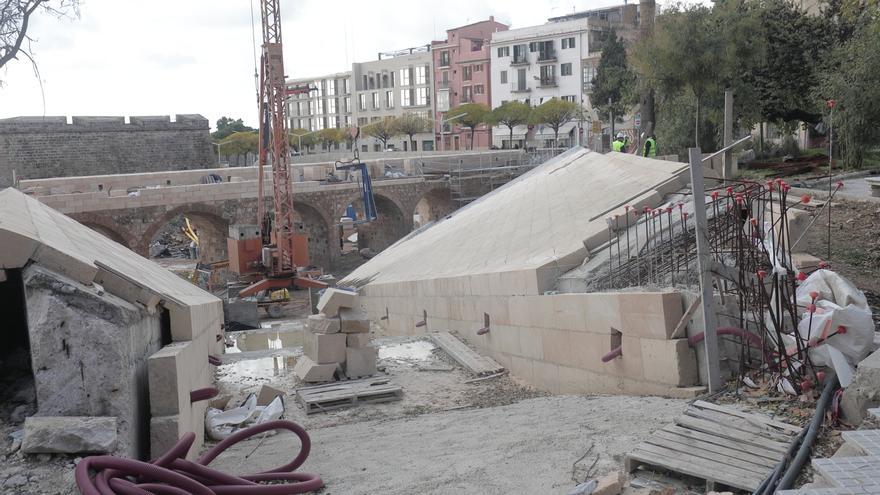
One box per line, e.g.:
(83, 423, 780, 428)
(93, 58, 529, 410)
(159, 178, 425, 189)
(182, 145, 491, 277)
(360, 271, 698, 396)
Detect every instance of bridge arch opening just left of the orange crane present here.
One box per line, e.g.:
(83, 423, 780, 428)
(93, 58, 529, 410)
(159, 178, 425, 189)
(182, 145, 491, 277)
(139, 203, 229, 263)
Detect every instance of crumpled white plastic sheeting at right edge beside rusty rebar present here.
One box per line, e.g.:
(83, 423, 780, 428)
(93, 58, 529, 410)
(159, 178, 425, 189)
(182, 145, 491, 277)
(795, 270, 874, 387)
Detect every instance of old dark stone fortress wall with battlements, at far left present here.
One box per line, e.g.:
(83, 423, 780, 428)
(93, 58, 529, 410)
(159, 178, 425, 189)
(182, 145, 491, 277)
(0, 115, 216, 187)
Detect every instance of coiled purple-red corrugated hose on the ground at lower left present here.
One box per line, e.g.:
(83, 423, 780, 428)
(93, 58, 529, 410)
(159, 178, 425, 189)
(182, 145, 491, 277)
(75, 420, 324, 495)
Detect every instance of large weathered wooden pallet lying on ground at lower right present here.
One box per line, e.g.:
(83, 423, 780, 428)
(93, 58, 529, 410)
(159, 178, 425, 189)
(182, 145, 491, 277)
(626, 401, 801, 491)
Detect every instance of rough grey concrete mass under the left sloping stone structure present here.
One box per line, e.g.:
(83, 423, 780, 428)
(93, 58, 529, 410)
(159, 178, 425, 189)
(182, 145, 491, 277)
(24, 264, 161, 458)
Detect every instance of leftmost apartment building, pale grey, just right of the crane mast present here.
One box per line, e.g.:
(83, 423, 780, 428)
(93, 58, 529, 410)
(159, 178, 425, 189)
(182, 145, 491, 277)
(287, 72, 354, 145)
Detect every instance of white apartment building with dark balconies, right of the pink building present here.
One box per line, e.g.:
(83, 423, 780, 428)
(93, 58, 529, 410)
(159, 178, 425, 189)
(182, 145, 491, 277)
(491, 4, 639, 148)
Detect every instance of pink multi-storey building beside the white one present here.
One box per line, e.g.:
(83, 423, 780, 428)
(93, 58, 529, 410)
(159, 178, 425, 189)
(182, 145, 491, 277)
(431, 16, 507, 150)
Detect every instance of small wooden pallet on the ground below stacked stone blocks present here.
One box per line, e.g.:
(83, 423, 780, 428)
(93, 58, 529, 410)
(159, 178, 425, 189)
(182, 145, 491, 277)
(296, 378, 403, 414)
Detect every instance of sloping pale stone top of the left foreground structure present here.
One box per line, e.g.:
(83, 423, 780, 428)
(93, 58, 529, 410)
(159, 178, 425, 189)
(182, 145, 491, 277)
(0, 188, 219, 306)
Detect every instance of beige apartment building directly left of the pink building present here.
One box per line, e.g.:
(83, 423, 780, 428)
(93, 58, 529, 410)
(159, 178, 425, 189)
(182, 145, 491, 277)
(351, 45, 434, 151)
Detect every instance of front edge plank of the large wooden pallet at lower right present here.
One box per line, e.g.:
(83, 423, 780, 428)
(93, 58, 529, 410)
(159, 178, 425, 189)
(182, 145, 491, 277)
(627, 446, 762, 491)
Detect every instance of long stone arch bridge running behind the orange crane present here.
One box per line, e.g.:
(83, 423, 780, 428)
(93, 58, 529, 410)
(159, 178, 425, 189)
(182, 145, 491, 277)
(20, 167, 455, 270)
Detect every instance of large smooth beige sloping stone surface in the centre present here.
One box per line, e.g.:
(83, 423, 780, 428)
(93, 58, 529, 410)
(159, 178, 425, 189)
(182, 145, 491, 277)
(339, 148, 687, 286)
